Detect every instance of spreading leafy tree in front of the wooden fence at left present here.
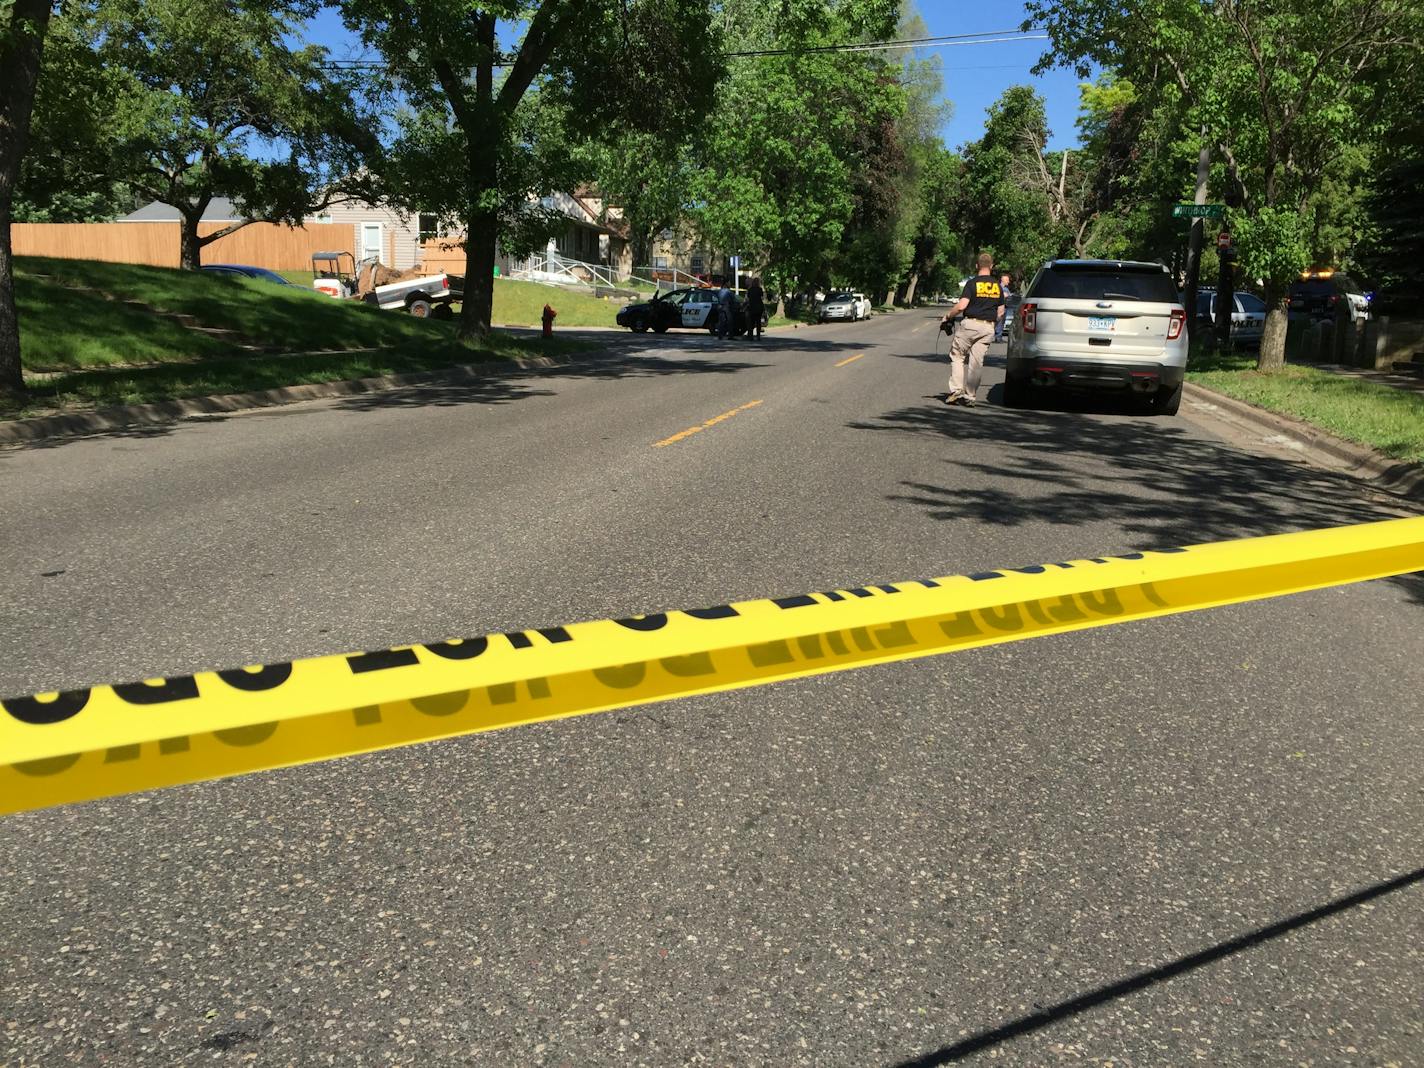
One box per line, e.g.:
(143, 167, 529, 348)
(97, 0, 379, 269)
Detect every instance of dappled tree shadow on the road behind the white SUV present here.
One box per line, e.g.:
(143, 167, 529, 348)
(849, 386, 1424, 604)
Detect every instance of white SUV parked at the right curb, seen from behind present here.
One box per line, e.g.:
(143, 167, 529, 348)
(1004, 259, 1186, 416)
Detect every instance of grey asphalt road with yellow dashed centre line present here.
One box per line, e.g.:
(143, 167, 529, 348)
(0, 312, 1424, 1067)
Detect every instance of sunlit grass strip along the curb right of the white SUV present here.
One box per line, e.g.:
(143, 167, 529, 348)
(1188, 353, 1424, 461)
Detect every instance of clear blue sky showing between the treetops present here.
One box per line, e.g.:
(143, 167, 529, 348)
(300, 0, 1078, 150)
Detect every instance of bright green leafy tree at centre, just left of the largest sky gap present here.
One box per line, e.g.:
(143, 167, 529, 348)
(693, 0, 904, 301)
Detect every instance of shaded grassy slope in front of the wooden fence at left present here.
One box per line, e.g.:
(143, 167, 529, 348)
(0, 258, 587, 419)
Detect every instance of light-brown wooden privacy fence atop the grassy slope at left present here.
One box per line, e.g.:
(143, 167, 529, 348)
(10, 222, 356, 271)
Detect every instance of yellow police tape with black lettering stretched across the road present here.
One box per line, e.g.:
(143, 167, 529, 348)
(0, 517, 1424, 813)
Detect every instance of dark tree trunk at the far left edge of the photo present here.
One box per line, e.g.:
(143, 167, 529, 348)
(0, 0, 51, 396)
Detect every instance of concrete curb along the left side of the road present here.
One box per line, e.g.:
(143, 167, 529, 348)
(0, 356, 571, 444)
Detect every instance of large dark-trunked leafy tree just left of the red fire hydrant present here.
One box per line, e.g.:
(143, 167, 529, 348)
(340, 0, 719, 337)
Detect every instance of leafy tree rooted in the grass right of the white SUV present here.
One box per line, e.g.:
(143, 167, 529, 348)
(1027, 0, 1424, 370)
